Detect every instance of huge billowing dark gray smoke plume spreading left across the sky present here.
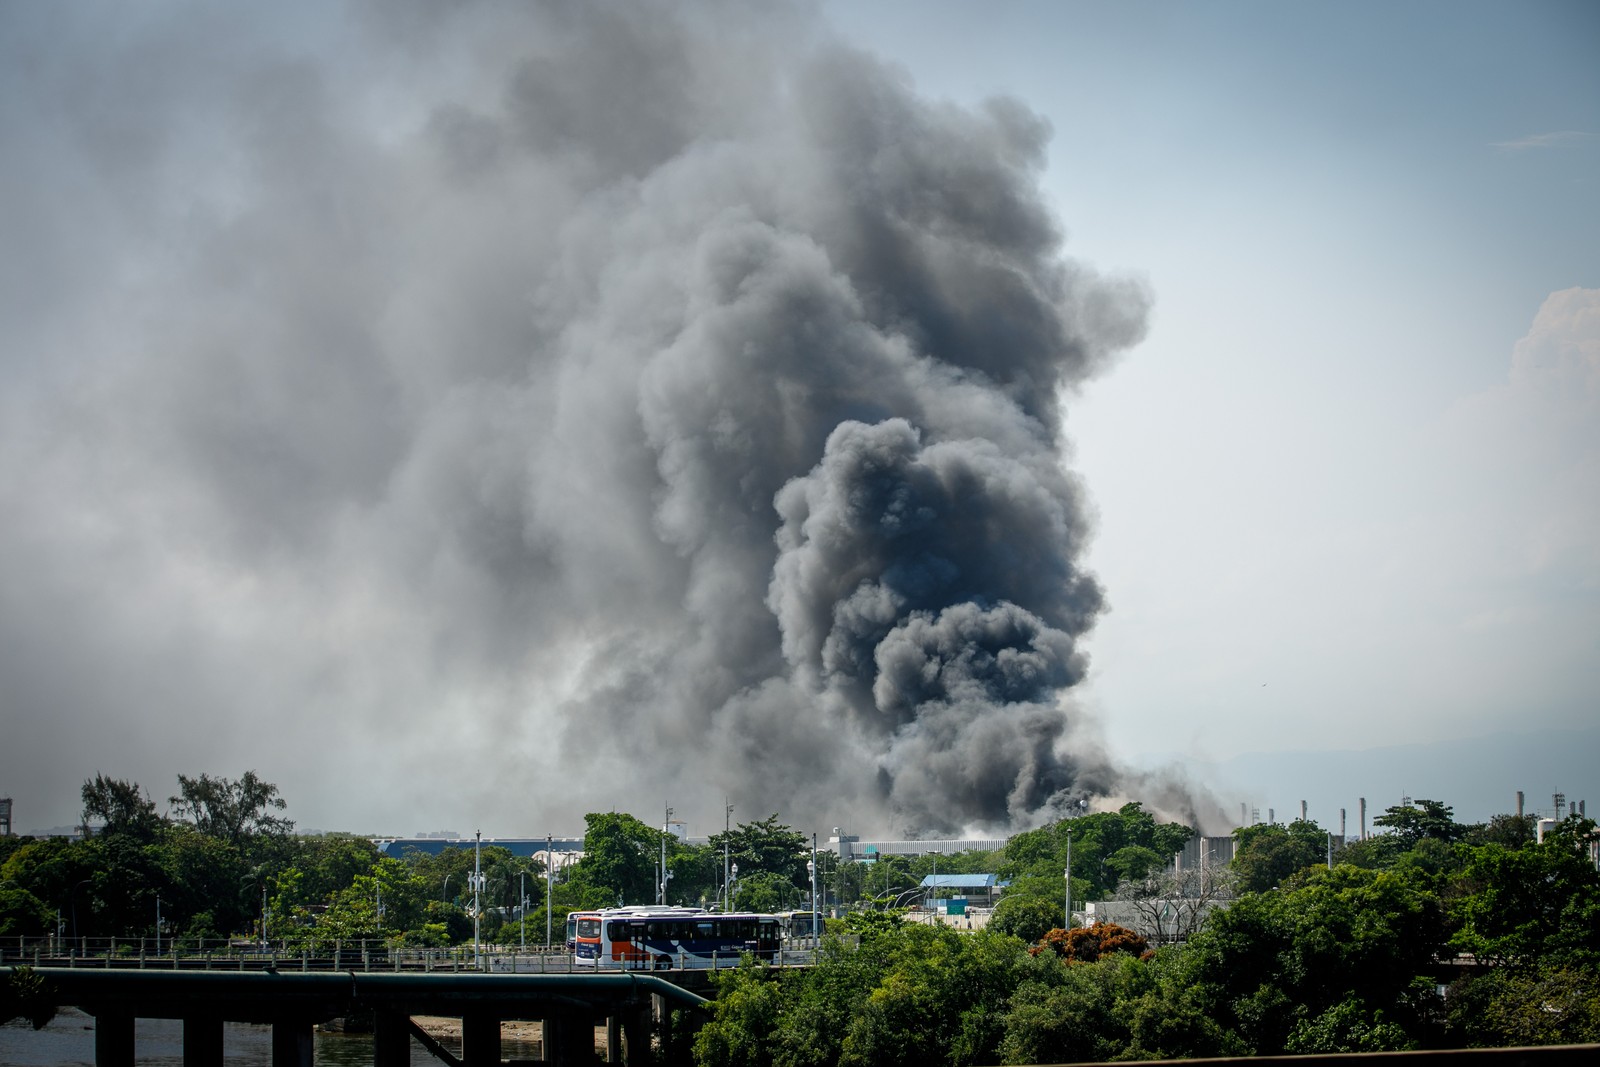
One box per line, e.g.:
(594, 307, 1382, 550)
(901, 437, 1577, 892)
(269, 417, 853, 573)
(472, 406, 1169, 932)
(0, 3, 1147, 830)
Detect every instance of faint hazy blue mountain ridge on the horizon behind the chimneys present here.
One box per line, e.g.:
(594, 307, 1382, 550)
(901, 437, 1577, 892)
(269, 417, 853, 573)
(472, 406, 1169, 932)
(1168, 728, 1600, 833)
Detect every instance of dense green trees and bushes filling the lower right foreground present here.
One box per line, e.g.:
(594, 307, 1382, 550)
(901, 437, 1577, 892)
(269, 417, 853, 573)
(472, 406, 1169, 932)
(694, 801, 1600, 1067)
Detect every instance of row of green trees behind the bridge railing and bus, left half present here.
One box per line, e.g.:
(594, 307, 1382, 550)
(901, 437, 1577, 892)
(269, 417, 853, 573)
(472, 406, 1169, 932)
(0, 771, 854, 947)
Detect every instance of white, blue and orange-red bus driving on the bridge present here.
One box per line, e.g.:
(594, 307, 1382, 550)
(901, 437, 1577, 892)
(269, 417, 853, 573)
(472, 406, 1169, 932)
(573, 907, 782, 969)
